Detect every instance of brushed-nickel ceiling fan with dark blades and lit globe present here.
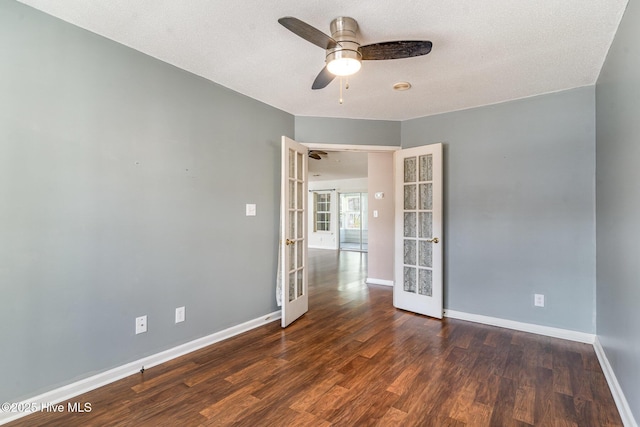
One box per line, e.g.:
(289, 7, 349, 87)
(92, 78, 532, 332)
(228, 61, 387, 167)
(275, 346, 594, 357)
(278, 16, 432, 89)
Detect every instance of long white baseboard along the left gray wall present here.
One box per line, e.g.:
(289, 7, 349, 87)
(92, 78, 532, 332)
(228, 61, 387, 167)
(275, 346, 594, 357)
(0, 311, 281, 425)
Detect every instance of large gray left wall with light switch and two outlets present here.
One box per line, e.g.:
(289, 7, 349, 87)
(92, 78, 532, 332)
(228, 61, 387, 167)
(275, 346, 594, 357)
(0, 1, 294, 402)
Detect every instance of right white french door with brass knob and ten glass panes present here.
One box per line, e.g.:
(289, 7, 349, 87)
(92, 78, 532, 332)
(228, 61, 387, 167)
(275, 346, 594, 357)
(393, 144, 443, 319)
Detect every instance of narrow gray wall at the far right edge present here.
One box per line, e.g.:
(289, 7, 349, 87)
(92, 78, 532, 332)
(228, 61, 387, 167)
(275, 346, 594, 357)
(596, 1, 640, 421)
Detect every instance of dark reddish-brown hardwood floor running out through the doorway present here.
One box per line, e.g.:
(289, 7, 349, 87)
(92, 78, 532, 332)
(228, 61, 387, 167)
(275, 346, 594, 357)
(10, 250, 622, 426)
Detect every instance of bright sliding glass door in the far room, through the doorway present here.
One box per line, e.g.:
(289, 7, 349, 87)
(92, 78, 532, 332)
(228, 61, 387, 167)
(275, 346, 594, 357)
(339, 193, 369, 252)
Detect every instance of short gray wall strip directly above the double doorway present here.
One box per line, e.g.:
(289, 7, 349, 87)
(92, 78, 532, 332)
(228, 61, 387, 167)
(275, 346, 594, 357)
(295, 116, 400, 146)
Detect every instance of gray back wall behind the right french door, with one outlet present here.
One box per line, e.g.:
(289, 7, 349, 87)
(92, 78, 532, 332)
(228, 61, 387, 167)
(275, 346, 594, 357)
(402, 87, 595, 333)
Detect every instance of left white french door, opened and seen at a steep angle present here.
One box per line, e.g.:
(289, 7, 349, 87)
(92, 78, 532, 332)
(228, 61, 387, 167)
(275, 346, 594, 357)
(280, 136, 309, 328)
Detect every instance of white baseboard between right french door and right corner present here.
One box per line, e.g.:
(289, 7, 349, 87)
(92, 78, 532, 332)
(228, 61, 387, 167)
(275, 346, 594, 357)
(444, 310, 596, 344)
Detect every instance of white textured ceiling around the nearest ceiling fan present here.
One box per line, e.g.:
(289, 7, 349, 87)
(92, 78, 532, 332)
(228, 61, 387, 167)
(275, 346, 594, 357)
(21, 0, 627, 120)
